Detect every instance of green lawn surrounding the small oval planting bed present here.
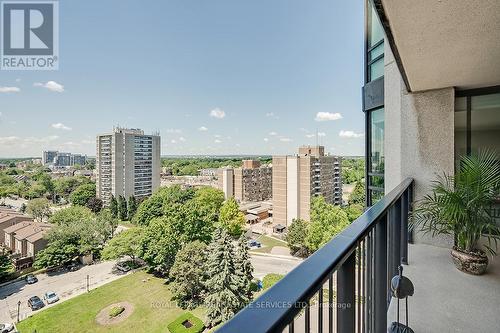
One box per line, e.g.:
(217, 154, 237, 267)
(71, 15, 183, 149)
(17, 271, 205, 333)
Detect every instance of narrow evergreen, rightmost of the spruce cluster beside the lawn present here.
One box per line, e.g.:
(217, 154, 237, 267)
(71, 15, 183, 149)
(235, 235, 253, 304)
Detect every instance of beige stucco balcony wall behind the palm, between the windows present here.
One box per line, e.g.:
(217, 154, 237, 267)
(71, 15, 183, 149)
(384, 42, 455, 247)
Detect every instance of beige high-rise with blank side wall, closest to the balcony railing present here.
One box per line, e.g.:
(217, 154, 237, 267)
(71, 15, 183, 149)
(273, 146, 342, 226)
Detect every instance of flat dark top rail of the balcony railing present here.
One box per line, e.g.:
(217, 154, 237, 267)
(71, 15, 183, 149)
(217, 178, 413, 333)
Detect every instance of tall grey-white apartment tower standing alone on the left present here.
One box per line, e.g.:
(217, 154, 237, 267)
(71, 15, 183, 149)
(96, 127, 161, 204)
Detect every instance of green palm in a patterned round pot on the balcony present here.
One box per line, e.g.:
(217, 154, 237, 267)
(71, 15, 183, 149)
(410, 151, 500, 275)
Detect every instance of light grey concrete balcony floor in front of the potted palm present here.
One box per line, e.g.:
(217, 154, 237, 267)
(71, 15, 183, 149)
(388, 244, 500, 333)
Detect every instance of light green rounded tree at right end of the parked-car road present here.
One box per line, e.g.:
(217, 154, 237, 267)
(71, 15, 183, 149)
(102, 228, 143, 262)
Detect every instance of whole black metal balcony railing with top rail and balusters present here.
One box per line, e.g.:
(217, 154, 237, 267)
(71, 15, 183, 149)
(217, 178, 413, 333)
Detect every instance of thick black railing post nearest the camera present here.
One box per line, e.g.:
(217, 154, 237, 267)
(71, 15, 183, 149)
(337, 251, 356, 332)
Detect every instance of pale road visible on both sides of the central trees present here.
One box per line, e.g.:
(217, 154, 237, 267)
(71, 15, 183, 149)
(0, 255, 301, 322)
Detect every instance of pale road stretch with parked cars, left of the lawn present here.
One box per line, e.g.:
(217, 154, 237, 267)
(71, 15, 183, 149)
(0, 261, 125, 322)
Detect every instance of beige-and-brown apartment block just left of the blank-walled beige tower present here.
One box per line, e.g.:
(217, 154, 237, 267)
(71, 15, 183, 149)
(218, 160, 273, 202)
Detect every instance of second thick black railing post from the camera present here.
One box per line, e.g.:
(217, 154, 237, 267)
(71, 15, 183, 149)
(376, 214, 387, 333)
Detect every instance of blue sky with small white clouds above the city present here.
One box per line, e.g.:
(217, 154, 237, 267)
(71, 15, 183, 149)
(0, 0, 364, 158)
